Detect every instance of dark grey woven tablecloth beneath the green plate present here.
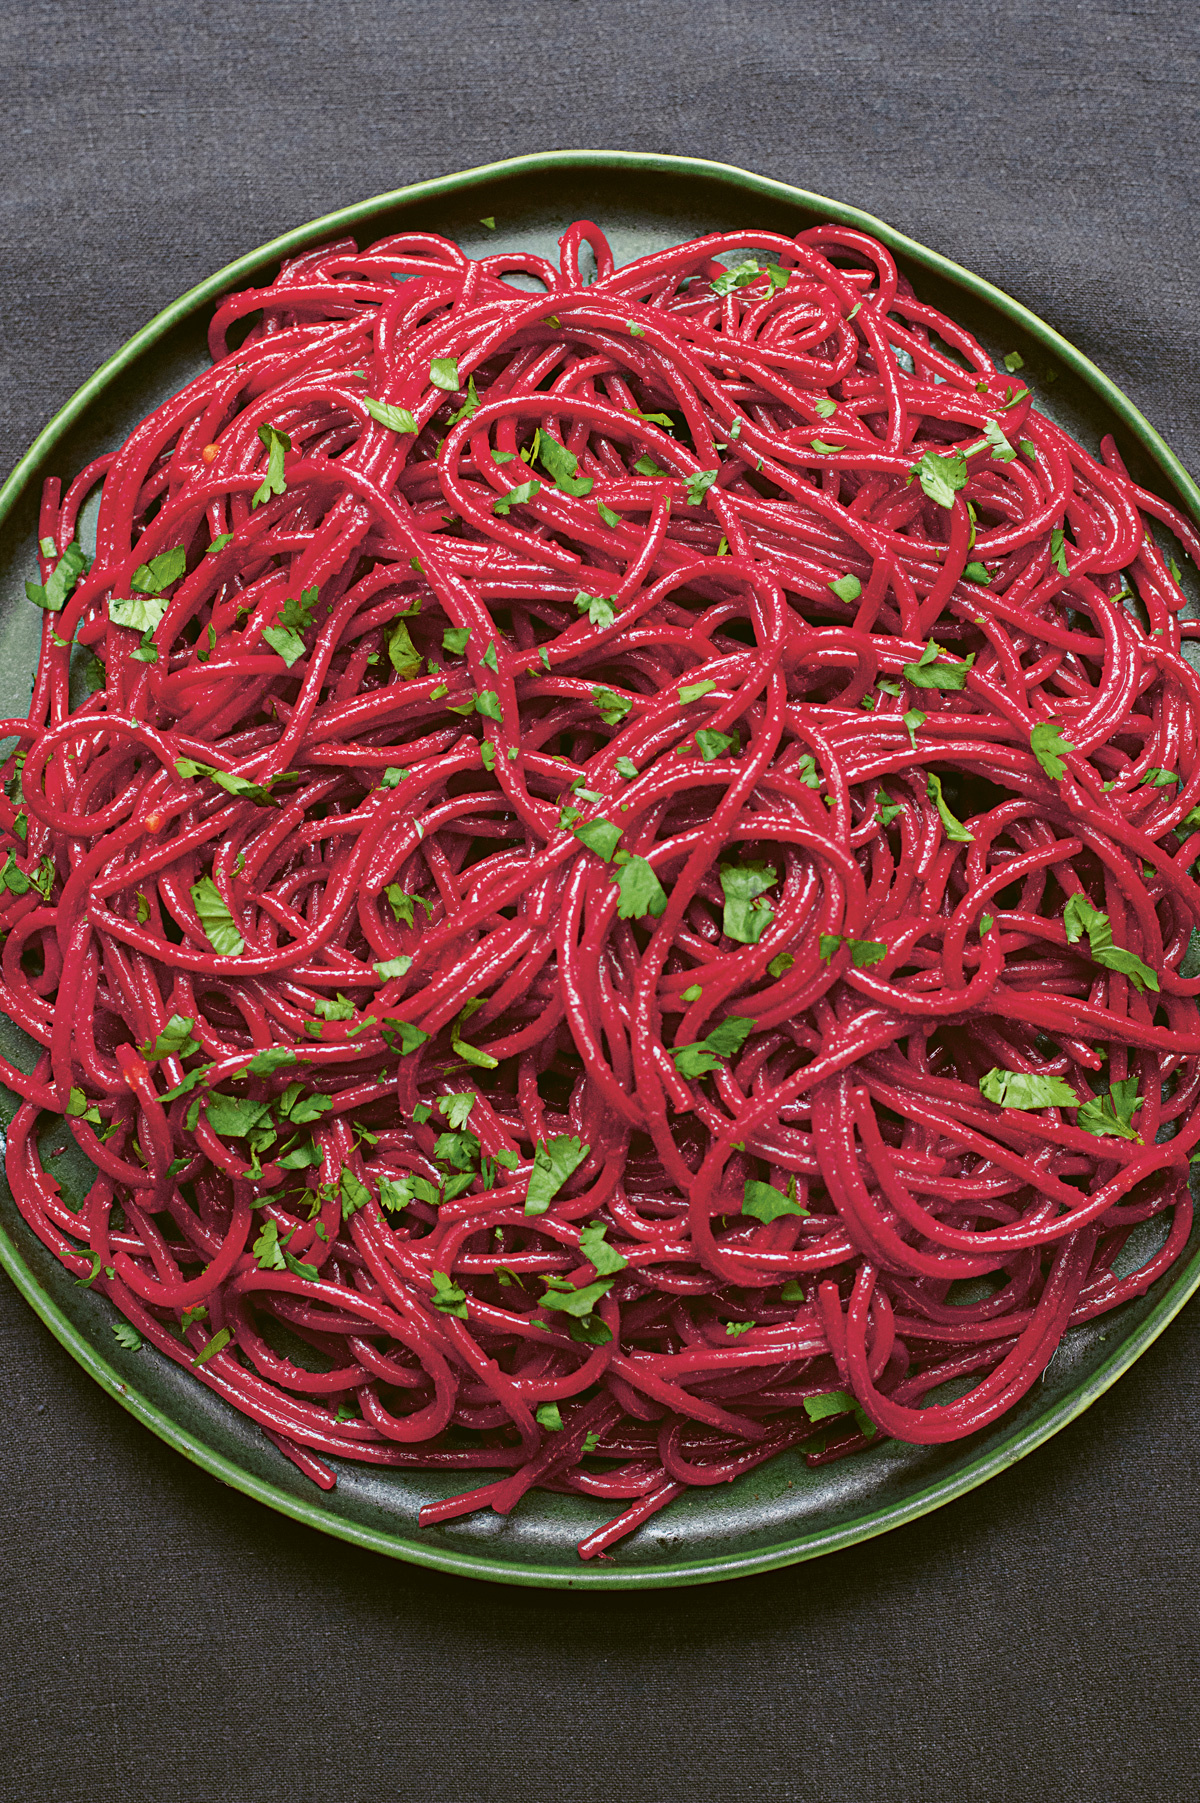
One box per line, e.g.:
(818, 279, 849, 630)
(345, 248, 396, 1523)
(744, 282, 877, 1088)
(0, 0, 1200, 1803)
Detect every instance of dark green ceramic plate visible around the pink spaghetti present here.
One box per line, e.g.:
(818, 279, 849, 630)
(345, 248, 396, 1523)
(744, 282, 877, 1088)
(0, 151, 1200, 1588)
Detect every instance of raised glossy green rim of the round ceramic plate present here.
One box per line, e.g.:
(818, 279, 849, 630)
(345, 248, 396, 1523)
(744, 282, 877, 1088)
(0, 150, 1200, 1590)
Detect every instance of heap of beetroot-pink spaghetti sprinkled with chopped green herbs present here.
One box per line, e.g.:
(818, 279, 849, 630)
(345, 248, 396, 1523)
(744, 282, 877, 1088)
(0, 222, 1200, 1558)
